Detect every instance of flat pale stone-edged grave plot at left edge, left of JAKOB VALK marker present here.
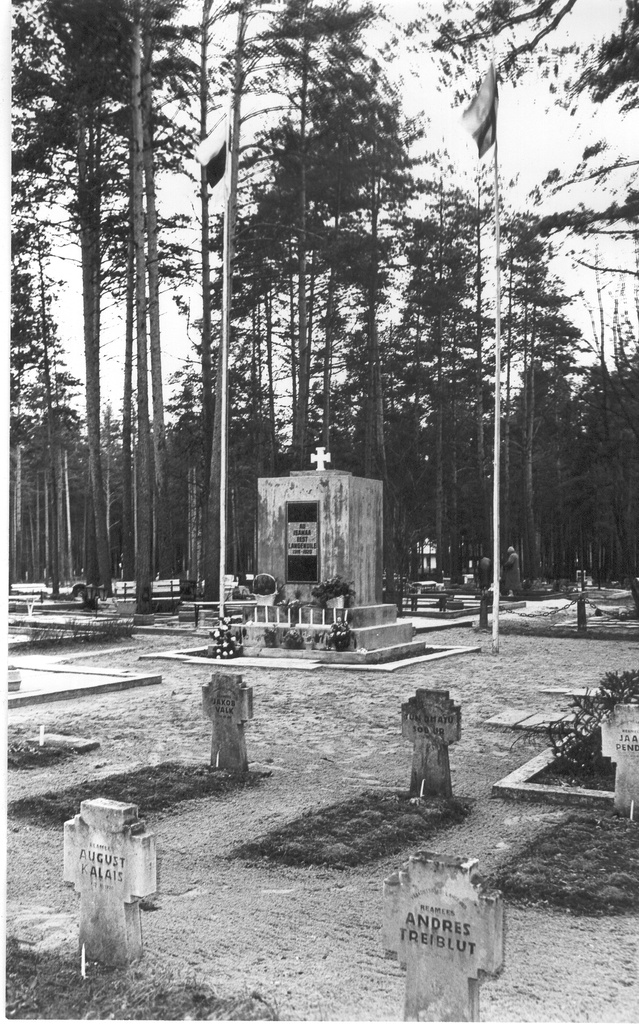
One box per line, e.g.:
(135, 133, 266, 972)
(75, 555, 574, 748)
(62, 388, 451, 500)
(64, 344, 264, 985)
(8, 651, 162, 710)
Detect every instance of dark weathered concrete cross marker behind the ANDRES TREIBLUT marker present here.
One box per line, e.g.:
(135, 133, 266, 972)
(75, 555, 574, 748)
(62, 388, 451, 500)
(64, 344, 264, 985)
(401, 689, 462, 797)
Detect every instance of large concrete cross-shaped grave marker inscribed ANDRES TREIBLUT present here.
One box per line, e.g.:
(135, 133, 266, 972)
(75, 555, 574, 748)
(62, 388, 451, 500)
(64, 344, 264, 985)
(382, 852, 504, 1021)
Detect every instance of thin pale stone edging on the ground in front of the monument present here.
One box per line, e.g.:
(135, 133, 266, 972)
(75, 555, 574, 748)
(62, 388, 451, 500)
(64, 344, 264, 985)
(139, 644, 481, 672)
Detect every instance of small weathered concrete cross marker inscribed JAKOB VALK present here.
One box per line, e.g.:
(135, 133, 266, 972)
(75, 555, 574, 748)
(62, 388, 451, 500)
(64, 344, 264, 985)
(202, 672, 253, 772)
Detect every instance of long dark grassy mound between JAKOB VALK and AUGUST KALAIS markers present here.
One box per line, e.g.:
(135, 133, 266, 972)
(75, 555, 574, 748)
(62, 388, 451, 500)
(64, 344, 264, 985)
(8, 761, 269, 825)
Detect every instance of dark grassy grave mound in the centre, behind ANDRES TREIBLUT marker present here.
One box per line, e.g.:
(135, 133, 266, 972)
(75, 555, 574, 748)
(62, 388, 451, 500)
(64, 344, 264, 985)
(229, 792, 471, 868)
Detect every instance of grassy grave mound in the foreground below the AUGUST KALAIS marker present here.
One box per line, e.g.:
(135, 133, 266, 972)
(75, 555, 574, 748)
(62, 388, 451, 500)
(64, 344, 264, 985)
(5, 939, 278, 1021)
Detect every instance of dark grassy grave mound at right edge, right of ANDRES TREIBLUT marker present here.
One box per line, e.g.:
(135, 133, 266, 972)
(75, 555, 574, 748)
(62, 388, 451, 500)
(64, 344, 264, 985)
(488, 814, 639, 915)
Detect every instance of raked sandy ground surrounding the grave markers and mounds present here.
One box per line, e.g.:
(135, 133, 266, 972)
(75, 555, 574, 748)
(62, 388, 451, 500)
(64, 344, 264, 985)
(7, 629, 639, 1022)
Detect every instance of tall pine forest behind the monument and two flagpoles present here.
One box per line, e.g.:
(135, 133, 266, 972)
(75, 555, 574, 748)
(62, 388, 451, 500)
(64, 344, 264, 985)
(9, 0, 639, 610)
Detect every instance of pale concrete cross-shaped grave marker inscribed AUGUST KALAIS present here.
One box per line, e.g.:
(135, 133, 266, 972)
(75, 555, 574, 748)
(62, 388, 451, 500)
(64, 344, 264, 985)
(63, 799, 157, 965)
